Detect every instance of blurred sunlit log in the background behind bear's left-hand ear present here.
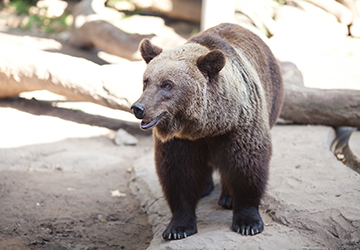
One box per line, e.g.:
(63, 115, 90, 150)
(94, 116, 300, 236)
(69, 0, 185, 61)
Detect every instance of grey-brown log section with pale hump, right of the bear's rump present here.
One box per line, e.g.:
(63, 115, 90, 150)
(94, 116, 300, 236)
(280, 62, 360, 128)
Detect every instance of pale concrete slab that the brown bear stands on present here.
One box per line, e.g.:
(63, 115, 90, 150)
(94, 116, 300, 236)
(130, 125, 360, 249)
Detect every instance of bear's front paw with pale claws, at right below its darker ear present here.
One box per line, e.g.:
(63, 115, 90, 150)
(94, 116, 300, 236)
(231, 207, 264, 235)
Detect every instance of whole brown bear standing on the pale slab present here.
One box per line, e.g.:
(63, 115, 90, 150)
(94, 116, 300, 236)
(132, 24, 283, 240)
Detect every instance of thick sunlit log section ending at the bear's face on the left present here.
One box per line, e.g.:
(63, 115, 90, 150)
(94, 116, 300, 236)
(0, 46, 145, 112)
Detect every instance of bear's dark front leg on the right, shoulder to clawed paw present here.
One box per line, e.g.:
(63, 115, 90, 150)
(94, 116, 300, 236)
(219, 134, 271, 235)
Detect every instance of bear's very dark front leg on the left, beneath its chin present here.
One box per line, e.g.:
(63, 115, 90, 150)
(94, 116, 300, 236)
(154, 137, 213, 240)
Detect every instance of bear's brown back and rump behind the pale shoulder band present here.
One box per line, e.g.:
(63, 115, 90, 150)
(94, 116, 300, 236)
(188, 23, 284, 127)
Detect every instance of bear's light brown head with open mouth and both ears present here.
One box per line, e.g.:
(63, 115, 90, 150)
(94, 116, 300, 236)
(131, 39, 226, 141)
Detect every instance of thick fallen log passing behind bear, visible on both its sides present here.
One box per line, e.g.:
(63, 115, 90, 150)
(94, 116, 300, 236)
(0, 46, 360, 128)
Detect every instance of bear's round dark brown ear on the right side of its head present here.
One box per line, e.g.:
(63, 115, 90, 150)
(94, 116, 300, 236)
(196, 49, 226, 79)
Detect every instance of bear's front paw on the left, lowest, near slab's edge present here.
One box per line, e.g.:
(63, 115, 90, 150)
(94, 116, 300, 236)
(162, 217, 197, 240)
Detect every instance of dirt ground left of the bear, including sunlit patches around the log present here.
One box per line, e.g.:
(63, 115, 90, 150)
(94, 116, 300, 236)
(0, 8, 159, 250)
